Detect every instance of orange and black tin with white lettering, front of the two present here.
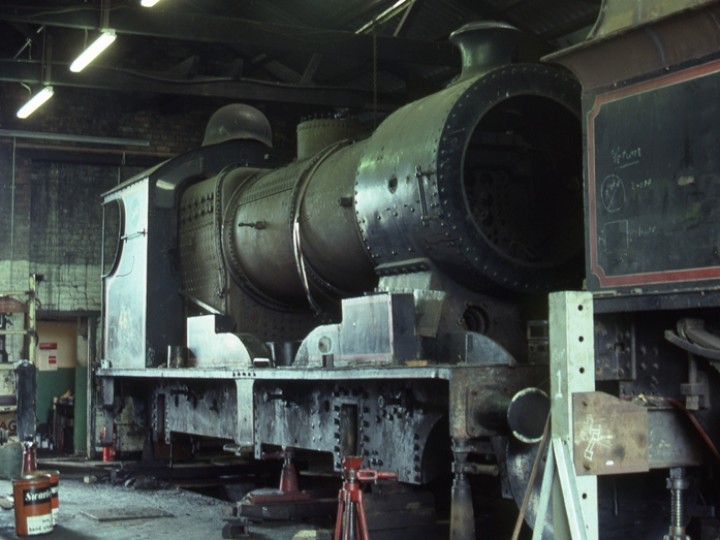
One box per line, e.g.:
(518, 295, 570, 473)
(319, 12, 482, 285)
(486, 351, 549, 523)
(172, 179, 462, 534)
(13, 472, 53, 536)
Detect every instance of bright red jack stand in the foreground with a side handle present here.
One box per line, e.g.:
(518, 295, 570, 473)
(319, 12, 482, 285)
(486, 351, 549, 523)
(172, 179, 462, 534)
(334, 456, 397, 540)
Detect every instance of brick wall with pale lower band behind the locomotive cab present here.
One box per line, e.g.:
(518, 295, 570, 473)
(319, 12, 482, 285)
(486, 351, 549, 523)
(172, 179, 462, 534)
(0, 83, 306, 360)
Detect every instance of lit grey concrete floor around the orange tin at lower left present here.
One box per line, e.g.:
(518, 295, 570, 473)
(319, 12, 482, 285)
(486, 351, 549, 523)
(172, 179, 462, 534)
(0, 473, 326, 540)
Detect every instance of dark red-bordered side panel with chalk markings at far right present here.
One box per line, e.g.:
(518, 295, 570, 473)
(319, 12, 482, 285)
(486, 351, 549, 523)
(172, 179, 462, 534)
(586, 60, 720, 291)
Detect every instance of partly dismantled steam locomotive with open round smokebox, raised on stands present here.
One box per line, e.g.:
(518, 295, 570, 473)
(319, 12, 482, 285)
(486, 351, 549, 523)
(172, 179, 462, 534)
(97, 23, 583, 538)
